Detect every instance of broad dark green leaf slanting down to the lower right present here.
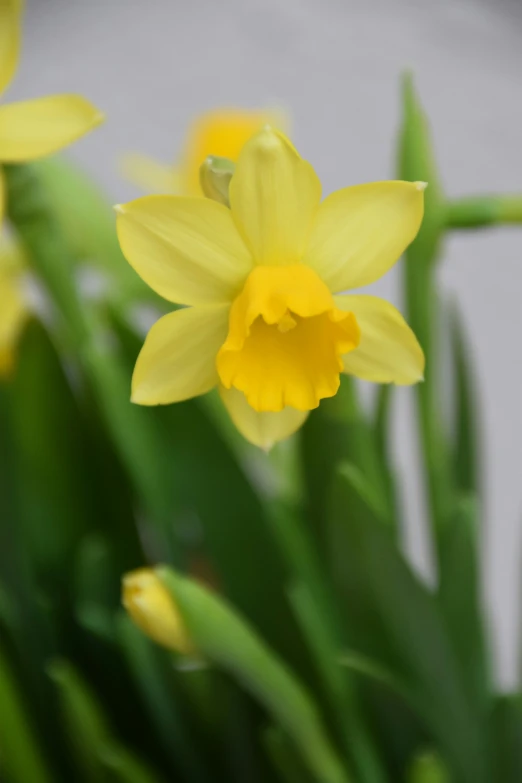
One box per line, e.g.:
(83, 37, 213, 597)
(331, 469, 489, 783)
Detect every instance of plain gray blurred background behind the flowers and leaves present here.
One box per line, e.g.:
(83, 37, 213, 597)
(8, 0, 522, 686)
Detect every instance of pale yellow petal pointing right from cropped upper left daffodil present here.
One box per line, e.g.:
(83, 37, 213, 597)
(0, 95, 103, 163)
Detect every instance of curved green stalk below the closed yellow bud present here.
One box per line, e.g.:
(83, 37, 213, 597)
(157, 568, 350, 783)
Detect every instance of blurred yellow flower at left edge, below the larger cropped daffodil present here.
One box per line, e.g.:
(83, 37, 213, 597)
(0, 235, 27, 380)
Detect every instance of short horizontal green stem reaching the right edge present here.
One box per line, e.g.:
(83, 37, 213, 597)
(446, 195, 522, 229)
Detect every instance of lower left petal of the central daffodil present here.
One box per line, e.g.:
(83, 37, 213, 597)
(132, 306, 228, 405)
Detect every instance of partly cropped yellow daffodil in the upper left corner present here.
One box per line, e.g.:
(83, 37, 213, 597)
(0, 0, 103, 217)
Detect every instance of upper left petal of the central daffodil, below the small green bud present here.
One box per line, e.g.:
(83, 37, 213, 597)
(117, 196, 253, 305)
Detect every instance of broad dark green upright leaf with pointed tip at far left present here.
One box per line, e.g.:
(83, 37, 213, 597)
(11, 321, 94, 578)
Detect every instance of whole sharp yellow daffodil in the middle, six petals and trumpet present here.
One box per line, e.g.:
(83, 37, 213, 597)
(117, 127, 425, 449)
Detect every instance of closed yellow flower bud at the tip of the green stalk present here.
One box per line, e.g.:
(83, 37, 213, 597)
(122, 568, 195, 655)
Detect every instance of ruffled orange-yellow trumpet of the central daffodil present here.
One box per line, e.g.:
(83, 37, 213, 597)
(216, 264, 359, 412)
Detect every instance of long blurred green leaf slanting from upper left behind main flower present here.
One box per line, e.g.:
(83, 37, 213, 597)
(5, 166, 179, 564)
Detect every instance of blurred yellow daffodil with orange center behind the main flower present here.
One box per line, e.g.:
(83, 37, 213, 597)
(123, 109, 281, 196)
